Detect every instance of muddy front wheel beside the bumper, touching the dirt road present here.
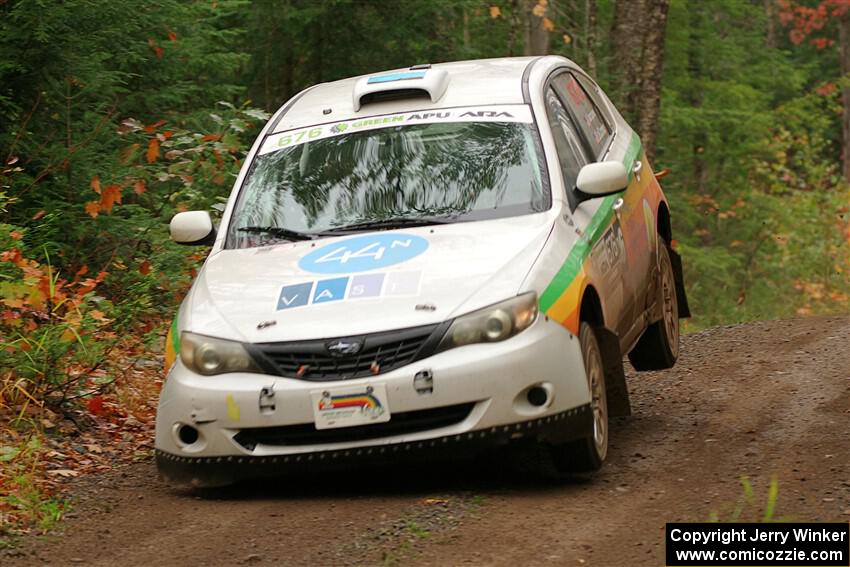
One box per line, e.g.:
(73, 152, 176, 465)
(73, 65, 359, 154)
(551, 322, 608, 473)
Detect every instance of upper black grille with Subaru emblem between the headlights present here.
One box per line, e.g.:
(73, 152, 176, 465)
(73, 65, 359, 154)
(248, 323, 447, 381)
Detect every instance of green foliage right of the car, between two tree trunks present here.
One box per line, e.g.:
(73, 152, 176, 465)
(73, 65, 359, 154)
(656, 0, 850, 330)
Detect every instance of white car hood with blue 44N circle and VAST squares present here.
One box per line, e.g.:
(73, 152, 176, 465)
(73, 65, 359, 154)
(185, 213, 553, 342)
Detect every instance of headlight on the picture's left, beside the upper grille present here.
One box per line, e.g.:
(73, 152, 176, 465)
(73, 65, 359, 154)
(180, 331, 262, 376)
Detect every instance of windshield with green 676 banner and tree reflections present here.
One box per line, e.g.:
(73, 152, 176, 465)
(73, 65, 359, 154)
(228, 106, 550, 248)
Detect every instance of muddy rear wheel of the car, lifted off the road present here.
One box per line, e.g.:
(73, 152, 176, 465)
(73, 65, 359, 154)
(629, 240, 679, 371)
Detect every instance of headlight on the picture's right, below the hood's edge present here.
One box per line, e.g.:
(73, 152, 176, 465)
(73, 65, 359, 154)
(437, 291, 537, 351)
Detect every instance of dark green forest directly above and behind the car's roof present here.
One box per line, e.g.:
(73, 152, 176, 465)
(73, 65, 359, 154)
(235, 0, 523, 110)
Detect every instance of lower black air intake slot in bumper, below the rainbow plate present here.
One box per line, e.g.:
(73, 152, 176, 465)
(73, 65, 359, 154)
(233, 402, 475, 451)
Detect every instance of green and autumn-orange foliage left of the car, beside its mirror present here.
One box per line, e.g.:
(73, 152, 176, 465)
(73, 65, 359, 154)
(0, 0, 268, 418)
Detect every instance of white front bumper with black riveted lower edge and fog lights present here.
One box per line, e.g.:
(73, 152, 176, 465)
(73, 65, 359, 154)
(156, 315, 592, 485)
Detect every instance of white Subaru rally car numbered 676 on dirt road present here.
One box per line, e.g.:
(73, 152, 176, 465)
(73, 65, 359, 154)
(156, 56, 687, 486)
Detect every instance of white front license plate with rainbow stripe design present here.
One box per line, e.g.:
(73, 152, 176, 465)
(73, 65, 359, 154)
(310, 384, 390, 429)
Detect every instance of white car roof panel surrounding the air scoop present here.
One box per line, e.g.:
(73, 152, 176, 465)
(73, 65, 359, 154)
(269, 57, 536, 133)
